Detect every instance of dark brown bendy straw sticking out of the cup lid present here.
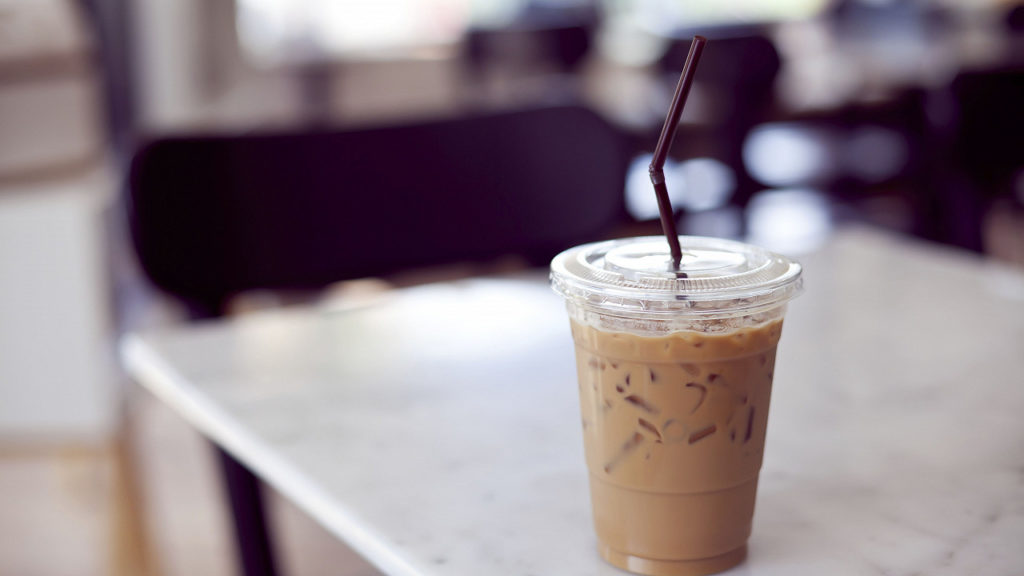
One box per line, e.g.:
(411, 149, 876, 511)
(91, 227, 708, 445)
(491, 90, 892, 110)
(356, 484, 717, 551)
(649, 36, 708, 271)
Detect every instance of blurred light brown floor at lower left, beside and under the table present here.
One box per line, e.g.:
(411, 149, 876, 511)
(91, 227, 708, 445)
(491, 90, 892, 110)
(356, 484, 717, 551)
(0, 392, 378, 576)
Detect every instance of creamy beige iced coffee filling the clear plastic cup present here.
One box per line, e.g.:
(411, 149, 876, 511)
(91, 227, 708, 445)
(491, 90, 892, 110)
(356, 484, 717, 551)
(572, 320, 782, 575)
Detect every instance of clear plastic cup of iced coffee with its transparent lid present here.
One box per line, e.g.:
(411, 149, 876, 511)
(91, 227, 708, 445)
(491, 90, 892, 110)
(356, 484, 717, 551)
(551, 237, 802, 576)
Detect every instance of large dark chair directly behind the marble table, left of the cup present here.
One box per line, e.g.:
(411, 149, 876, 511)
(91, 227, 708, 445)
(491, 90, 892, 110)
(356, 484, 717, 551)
(129, 108, 627, 575)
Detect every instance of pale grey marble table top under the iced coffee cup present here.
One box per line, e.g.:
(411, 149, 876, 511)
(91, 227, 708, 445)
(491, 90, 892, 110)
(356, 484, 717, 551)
(122, 230, 1024, 576)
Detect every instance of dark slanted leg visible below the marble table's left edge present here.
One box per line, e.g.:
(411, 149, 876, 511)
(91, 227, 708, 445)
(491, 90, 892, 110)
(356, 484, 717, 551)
(217, 446, 278, 576)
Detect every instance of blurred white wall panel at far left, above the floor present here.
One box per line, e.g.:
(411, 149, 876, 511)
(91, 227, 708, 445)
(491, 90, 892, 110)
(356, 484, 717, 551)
(0, 173, 118, 442)
